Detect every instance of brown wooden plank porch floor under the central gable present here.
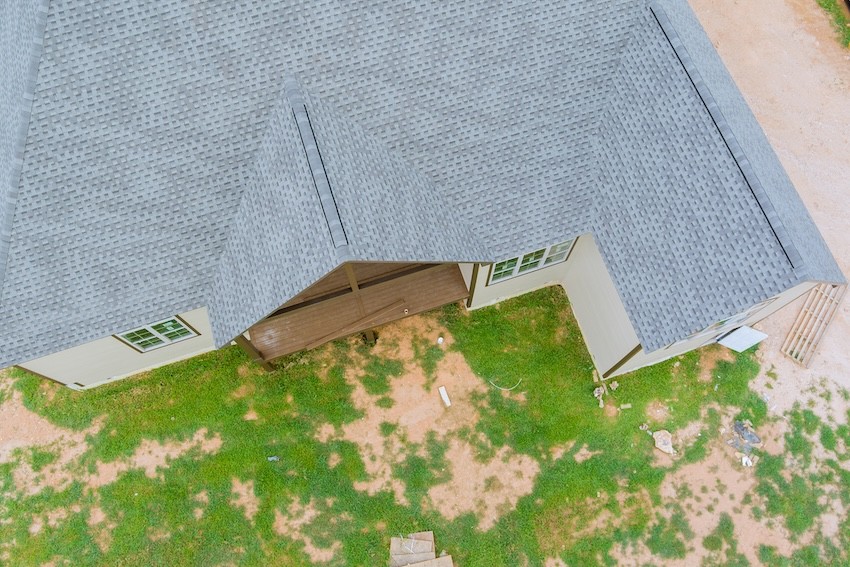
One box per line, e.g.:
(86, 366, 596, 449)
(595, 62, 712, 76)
(249, 264, 469, 361)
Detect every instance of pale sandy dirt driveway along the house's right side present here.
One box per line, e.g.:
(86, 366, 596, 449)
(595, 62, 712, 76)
(690, 0, 850, 404)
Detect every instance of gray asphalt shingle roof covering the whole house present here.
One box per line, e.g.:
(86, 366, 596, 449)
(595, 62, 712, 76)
(0, 0, 842, 365)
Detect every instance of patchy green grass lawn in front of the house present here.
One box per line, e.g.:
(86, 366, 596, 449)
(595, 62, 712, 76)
(0, 289, 850, 567)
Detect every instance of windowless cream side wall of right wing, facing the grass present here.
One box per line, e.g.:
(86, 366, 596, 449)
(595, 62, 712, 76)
(563, 235, 640, 375)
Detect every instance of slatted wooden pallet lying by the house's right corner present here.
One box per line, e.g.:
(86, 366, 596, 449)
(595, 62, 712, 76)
(781, 284, 847, 368)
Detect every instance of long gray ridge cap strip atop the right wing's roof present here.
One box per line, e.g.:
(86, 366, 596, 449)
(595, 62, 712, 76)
(649, 0, 803, 269)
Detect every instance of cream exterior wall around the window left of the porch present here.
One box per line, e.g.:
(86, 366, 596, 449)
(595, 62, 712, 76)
(19, 307, 215, 389)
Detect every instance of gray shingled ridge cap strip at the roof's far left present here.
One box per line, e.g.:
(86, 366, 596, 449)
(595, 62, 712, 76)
(0, 0, 50, 306)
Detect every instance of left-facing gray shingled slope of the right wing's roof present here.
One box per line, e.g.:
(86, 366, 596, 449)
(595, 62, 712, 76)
(594, 7, 798, 352)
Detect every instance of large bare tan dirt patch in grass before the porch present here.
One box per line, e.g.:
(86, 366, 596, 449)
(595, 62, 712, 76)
(317, 316, 544, 530)
